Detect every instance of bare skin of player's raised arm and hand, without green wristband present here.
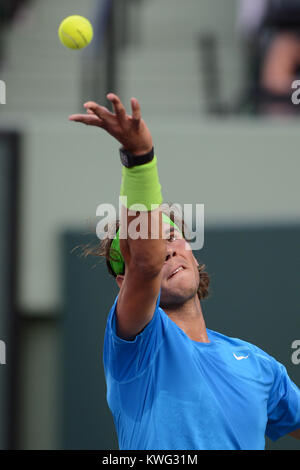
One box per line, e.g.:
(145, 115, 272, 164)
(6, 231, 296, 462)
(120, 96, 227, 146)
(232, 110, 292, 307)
(69, 93, 166, 340)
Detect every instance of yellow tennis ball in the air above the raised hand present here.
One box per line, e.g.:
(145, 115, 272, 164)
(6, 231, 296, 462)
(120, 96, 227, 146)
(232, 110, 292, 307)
(58, 15, 93, 49)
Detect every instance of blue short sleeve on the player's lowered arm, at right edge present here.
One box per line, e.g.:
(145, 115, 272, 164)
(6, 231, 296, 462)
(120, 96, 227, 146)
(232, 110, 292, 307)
(266, 359, 300, 441)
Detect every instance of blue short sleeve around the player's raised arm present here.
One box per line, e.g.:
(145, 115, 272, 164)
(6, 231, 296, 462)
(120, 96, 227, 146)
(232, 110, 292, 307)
(103, 293, 166, 383)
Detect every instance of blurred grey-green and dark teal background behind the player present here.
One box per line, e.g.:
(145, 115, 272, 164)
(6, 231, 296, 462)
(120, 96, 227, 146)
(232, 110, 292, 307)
(0, 0, 300, 449)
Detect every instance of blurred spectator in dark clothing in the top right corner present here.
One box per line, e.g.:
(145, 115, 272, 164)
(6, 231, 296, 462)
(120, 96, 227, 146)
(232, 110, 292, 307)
(238, 0, 300, 114)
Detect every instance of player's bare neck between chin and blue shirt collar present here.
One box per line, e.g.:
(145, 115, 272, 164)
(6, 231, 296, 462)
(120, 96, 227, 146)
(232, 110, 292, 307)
(164, 294, 210, 343)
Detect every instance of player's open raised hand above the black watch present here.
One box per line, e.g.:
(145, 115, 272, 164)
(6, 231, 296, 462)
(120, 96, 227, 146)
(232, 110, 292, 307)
(69, 93, 153, 155)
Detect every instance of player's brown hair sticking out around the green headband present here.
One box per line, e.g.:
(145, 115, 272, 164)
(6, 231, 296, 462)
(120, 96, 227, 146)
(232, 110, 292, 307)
(83, 209, 210, 300)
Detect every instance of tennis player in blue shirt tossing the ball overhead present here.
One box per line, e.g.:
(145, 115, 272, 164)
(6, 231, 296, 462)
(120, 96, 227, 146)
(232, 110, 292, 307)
(70, 93, 300, 450)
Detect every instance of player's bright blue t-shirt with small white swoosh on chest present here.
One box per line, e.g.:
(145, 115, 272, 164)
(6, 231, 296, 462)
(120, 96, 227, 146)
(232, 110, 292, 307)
(103, 296, 300, 450)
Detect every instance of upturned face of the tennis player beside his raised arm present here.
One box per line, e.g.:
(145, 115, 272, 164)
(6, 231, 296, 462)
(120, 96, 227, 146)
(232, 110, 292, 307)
(160, 224, 199, 307)
